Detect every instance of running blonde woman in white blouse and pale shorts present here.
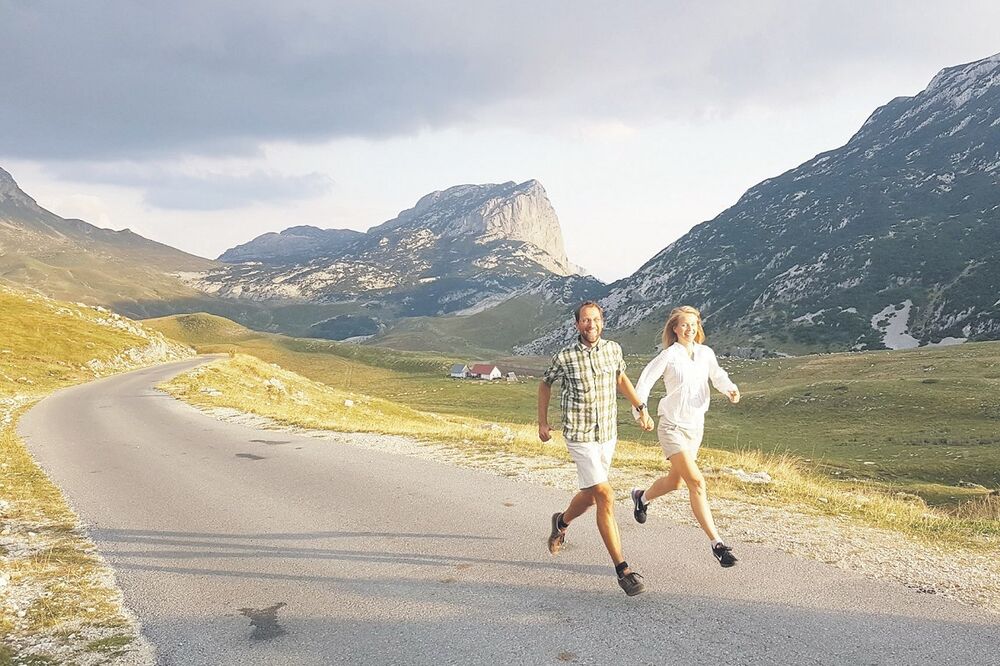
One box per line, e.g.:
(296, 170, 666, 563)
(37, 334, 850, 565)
(632, 305, 740, 567)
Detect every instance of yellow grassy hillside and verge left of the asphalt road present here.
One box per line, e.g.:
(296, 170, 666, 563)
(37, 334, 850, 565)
(0, 286, 190, 664)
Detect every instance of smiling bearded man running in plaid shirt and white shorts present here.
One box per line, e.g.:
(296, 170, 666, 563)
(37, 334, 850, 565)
(538, 301, 653, 597)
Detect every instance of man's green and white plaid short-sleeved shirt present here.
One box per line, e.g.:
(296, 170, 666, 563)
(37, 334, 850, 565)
(542, 338, 625, 442)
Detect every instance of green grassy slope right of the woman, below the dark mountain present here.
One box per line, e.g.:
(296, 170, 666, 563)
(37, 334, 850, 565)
(709, 342, 1000, 502)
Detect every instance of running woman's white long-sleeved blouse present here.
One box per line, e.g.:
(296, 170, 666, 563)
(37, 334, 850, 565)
(633, 342, 736, 429)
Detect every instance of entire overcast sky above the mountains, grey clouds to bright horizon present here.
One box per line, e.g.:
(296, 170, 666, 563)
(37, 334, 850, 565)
(0, 0, 1000, 281)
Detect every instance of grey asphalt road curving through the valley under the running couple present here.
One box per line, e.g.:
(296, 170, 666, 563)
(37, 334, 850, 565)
(19, 360, 1000, 666)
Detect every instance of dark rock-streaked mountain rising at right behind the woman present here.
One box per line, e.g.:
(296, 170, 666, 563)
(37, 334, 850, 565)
(520, 55, 1000, 353)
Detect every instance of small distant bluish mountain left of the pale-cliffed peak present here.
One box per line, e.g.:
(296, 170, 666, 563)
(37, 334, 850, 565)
(218, 226, 364, 264)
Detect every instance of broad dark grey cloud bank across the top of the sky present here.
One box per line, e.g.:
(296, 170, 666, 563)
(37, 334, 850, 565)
(0, 0, 1000, 160)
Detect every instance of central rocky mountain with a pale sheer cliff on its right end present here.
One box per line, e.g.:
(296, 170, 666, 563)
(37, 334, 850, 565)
(190, 180, 581, 320)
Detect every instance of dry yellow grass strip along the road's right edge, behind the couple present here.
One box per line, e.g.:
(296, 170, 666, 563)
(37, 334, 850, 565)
(163, 354, 1000, 552)
